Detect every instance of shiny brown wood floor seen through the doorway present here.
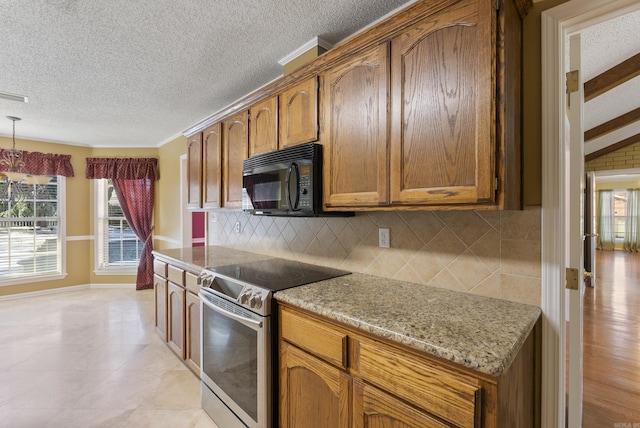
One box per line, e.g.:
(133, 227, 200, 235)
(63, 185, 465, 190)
(583, 251, 640, 428)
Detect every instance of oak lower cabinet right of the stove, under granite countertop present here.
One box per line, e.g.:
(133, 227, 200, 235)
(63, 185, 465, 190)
(279, 305, 539, 428)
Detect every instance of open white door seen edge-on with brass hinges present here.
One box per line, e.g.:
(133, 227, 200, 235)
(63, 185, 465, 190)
(565, 34, 585, 428)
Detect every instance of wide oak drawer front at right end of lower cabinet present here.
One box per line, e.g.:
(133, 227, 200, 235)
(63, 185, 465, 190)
(355, 340, 481, 427)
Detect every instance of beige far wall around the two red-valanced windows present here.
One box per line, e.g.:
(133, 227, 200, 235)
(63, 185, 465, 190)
(0, 137, 162, 296)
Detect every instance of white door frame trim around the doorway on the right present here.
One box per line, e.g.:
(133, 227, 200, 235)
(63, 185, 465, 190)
(541, 0, 640, 427)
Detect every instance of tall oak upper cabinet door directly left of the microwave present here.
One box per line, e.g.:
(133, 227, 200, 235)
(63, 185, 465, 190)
(222, 111, 249, 208)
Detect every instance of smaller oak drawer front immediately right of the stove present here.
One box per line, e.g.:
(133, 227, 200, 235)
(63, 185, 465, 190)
(280, 309, 348, 369)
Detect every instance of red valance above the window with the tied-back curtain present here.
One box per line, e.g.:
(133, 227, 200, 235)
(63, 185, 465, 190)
(85, 158, 159, 181)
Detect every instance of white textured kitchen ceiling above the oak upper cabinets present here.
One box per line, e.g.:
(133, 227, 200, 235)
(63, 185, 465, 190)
(0, 0, 413, 150)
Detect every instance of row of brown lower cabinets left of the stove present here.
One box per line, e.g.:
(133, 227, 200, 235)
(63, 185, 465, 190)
(153, 258, 200, 377)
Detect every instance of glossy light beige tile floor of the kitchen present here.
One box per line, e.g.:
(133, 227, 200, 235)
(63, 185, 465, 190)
(0, 289, 216, 428)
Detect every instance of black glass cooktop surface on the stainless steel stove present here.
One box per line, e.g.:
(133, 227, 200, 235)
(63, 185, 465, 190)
(209, 259, 351, 291)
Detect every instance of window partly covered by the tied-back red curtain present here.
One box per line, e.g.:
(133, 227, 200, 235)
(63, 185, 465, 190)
(94, 179, 144, 274)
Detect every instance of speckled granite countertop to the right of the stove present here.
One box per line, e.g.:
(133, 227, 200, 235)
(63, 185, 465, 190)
(275, 273, 542, 377)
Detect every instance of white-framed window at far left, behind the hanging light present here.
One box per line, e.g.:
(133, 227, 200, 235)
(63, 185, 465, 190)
(0, 176, 65, 285)
